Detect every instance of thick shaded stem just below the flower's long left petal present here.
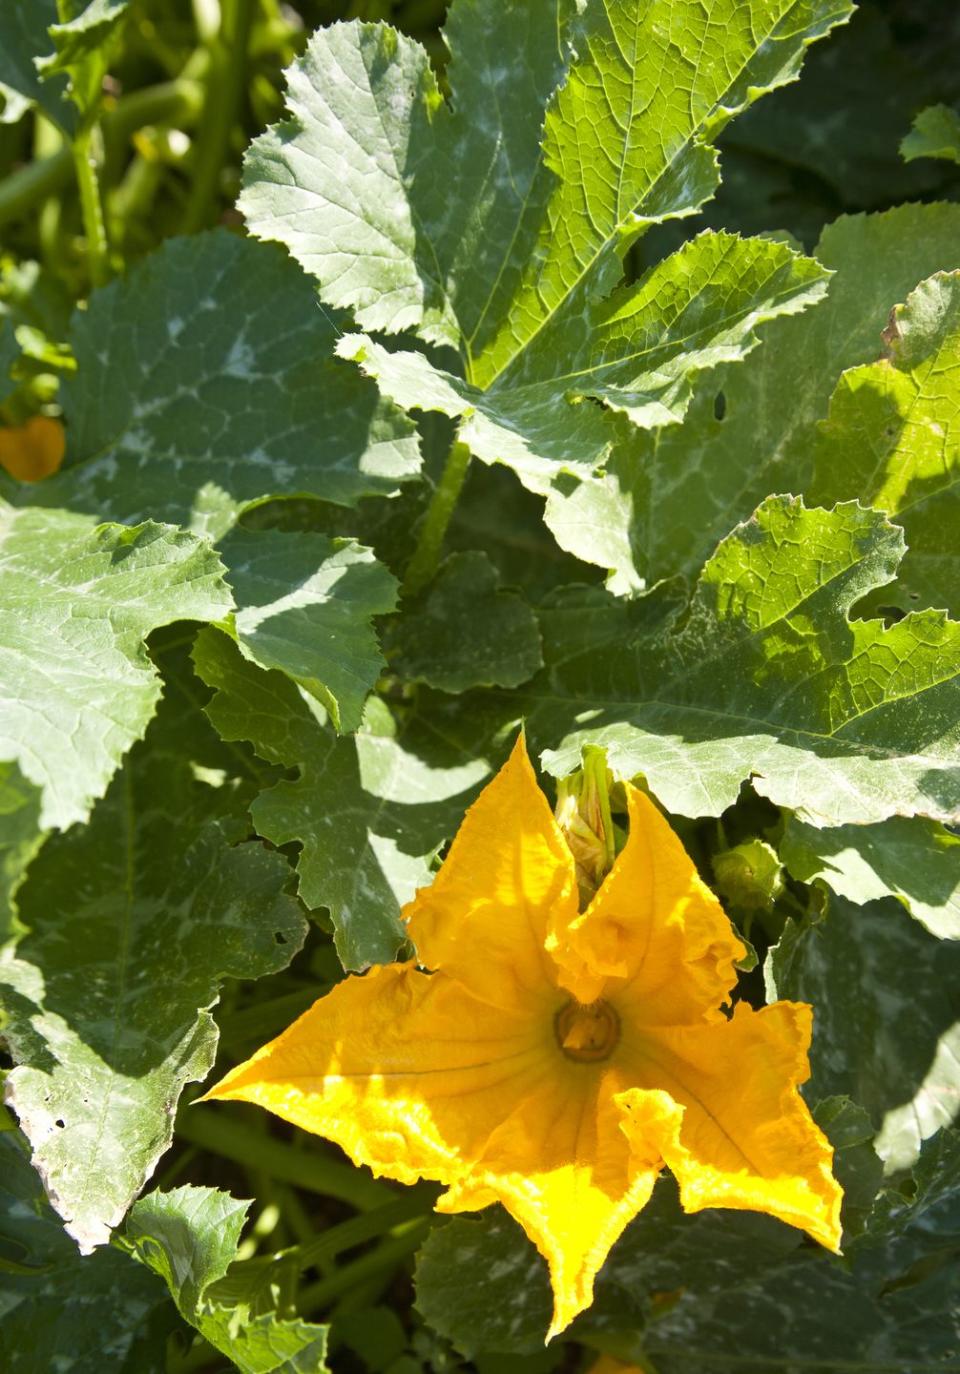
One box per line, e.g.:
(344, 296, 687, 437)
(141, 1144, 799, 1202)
(177, 1107, 394, 1212)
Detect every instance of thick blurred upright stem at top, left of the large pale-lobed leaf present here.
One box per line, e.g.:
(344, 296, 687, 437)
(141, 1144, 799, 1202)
(181, 0, 255, 234)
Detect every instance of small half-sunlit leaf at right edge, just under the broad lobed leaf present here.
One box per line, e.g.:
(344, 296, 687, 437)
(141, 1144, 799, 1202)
(780, 816, 960, 940)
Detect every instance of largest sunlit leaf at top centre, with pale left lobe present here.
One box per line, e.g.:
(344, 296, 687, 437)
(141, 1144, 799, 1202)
(247, 0, 852, 527)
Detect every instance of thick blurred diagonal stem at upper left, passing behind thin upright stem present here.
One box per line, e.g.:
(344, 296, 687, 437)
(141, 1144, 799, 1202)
(0, 81, 202, 225)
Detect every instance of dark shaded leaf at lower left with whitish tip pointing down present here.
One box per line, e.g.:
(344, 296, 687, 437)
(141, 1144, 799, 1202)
(0, 708, 306, 1252)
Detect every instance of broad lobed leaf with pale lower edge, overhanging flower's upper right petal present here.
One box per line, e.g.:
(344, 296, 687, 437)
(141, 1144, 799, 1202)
(538, 496, 960, 826)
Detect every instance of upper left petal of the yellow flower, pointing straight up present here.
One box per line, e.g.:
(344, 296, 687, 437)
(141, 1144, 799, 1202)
(404, 736, 577, 1007)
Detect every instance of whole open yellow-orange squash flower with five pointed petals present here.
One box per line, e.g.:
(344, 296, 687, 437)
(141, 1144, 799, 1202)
(209, 739, 841, 1340)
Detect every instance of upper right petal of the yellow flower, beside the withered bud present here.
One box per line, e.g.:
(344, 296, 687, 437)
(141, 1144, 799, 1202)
(553, 785, 746, 1025)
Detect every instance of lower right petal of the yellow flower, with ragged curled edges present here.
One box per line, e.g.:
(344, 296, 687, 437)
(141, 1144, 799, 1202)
(622, 1002, 842, 1250)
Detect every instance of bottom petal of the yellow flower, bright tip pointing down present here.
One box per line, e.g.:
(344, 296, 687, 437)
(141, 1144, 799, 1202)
(437, 1063, 664, 1340)
